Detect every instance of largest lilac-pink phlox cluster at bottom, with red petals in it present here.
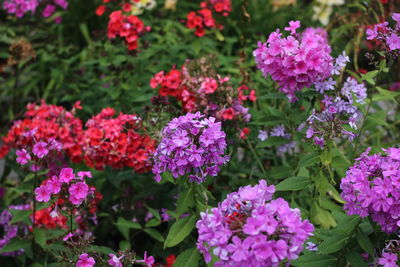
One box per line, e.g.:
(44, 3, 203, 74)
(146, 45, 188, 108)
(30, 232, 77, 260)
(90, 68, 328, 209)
(196, 180, 314, 266)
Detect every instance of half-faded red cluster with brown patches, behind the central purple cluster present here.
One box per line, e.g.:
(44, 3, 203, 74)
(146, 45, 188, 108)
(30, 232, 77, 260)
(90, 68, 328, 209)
(150, 57, 257, 122)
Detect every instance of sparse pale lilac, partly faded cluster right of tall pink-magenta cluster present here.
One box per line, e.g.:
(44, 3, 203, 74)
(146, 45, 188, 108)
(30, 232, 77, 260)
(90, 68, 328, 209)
(306, 52, 367, 148)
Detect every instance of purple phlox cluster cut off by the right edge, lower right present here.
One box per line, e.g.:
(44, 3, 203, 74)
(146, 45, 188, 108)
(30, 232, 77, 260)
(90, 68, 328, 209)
(340, 148, 400, 233)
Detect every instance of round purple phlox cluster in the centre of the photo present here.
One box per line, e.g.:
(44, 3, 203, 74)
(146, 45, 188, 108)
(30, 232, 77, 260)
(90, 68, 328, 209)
(153, 112, 229, 183)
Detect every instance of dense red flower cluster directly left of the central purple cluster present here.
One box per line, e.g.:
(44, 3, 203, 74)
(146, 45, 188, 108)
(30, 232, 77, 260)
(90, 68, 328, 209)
(83, 108, 155, 172)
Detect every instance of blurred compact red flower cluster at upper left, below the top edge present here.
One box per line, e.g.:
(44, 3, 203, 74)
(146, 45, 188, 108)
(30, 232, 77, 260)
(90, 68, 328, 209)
(108, 10, 150, 50)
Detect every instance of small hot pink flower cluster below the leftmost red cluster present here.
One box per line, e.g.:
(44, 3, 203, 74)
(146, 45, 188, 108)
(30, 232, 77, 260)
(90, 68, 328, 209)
(35, 168, 94, 206)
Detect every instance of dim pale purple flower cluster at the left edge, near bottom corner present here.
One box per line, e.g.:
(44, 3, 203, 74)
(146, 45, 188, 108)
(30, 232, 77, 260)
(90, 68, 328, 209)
(0, 205, 30, 256)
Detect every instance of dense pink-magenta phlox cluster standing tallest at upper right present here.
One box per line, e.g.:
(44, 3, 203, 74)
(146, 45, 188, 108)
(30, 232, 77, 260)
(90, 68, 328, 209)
(253, 21, 333, 102)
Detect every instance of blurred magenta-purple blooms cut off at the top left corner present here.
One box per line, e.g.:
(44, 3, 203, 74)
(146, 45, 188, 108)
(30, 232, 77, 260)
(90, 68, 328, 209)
(3, 0, 68, 23)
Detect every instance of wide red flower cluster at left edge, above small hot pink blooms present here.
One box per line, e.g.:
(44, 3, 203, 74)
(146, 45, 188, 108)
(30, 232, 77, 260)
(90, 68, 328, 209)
(0, 101, 83, 162)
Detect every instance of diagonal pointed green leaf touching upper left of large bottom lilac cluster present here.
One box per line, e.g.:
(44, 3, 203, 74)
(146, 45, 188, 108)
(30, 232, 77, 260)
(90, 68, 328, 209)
(164, 215, 196, 248)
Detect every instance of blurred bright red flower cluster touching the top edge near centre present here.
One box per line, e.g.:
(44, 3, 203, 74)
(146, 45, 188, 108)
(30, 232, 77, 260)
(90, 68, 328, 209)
(186, 0, 232, 37)
